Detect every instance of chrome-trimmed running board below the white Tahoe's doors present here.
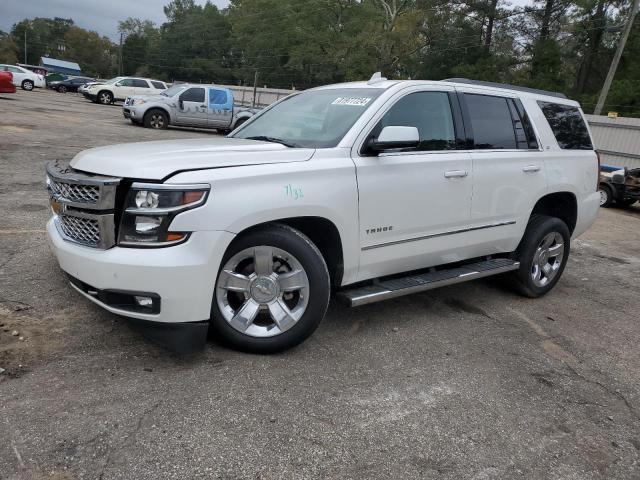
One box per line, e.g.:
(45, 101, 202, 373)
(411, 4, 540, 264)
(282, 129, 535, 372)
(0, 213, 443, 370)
(338, 258, 520, 307)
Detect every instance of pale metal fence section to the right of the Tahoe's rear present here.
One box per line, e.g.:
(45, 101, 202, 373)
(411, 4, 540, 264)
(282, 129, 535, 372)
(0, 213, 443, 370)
(585, 115, 640, 168)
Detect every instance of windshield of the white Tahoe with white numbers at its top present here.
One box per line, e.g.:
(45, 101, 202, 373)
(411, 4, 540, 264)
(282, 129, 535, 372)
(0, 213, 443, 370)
(232, 88, 384, 148)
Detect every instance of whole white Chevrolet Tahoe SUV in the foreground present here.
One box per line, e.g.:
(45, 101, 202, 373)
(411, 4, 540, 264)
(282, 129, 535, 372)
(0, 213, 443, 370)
(47, 75, 600, 352)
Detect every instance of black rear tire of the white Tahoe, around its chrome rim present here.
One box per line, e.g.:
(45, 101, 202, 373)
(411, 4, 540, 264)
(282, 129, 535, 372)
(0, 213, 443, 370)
(511, 215, 571, 298)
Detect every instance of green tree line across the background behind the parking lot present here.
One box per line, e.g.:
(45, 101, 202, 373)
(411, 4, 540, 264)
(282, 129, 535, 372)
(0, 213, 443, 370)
(0, 0, 640, 115)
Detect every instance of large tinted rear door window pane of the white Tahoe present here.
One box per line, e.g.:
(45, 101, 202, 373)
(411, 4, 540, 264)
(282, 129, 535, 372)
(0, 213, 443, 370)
(464, 93, 517, 149)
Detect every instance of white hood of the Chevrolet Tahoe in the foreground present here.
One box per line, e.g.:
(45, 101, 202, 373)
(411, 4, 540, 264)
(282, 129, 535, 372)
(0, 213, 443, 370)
(71, 137, 315, 180)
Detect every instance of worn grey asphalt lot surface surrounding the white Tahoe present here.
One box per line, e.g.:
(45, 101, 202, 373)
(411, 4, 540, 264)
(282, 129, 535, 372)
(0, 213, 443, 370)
(0, 90, 640, 480)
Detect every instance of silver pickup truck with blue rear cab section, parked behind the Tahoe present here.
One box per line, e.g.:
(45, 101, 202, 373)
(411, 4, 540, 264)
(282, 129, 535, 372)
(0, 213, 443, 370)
(122, 83, 257, 133)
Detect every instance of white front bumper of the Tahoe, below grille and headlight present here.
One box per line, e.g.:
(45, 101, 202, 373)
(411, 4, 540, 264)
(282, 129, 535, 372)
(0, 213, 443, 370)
(47, 218, 234, 324)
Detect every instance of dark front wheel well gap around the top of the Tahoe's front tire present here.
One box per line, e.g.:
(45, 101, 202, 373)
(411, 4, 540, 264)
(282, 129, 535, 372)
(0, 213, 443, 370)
(229, 216, 344, 286)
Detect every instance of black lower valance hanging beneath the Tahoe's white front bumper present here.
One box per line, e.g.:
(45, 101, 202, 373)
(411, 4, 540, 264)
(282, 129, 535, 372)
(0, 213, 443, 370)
(127, 318, 209, 354)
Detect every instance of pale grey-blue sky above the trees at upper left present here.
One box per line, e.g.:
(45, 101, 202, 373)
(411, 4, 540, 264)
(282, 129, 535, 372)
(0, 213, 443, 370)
(0, 0, 229, 41)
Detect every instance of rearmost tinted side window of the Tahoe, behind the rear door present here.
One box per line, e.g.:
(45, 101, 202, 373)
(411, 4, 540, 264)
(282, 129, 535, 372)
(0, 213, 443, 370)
(538, 102, 593, 150)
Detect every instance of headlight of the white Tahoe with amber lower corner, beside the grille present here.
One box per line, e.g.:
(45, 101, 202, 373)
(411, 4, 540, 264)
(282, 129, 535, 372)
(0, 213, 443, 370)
(118, 183, 211, 247)
